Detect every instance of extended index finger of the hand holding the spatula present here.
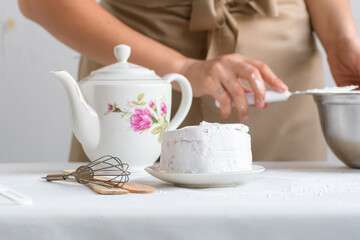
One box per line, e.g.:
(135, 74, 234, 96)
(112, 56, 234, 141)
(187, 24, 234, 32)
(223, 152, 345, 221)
(248, 59, 288, 92)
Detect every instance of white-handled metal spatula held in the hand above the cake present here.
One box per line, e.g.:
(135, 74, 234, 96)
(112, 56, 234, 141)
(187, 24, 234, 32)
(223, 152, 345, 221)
(215, 85, 359, 107)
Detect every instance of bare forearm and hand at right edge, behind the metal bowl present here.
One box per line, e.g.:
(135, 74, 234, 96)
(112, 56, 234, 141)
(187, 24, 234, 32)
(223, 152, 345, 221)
(306, 0, 360, 86)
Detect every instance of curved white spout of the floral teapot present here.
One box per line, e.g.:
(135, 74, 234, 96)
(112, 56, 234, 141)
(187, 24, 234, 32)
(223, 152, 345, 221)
(51, 70, 100, 149)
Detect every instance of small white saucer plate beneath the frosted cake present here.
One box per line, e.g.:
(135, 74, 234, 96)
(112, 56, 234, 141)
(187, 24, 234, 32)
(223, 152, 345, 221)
(145, 165, 265, 188)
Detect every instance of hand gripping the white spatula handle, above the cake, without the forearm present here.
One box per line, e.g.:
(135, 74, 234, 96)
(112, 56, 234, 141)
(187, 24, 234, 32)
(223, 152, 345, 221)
(180, 54, 288, 120)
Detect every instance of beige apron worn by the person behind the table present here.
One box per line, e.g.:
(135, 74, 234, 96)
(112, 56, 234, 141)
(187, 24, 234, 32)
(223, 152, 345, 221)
(70, 0, 326, 161)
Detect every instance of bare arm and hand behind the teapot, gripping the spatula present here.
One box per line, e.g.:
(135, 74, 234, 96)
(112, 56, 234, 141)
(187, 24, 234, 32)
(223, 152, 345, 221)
(19, 0, 287, 123)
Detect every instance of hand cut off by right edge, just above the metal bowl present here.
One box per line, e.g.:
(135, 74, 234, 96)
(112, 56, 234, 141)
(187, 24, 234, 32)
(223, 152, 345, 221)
(327, 36, 360, 86)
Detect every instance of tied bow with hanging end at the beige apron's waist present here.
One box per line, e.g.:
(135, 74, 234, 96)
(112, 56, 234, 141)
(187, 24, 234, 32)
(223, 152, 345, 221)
(189, 0, 279, 59)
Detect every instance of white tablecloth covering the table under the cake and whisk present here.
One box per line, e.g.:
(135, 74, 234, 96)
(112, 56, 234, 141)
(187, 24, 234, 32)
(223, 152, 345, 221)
(0, 162, 360, 240)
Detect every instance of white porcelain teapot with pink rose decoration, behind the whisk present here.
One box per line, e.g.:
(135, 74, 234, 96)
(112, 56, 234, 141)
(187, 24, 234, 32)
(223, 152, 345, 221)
(52, 45, 192, 171)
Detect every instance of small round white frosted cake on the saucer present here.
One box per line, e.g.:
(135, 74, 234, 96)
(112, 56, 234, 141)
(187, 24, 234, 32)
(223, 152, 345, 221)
(160, 122, 252, 173)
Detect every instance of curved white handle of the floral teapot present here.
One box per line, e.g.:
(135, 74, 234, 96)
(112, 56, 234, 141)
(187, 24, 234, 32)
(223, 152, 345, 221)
(163, 73, 192, 130)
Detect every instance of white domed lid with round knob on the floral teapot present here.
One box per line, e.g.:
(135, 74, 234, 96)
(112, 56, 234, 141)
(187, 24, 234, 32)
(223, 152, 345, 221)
(84, 44, 161, 81)
